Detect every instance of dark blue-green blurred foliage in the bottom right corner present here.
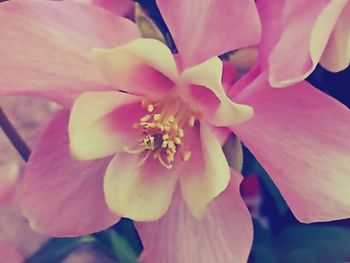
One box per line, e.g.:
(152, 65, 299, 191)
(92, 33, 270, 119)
(249, 221, 350, 263)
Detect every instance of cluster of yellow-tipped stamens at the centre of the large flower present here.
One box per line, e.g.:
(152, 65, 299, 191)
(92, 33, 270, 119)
(126, 99, 195, 169)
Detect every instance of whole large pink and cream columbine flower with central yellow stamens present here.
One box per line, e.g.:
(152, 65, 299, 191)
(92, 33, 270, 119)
(0, 0, 350, 263)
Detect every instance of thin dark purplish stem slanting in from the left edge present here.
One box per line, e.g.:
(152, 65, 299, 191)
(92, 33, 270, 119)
(0, 107, 30, 161)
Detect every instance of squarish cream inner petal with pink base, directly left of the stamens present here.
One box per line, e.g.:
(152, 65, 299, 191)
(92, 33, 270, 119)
(69, 91, 143, 160)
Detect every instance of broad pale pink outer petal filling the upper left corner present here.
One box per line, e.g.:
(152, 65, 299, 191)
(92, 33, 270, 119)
(0, 0, 139, 105)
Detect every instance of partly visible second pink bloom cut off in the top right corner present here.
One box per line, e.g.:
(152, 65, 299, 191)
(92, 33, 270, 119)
(257, 0, 350, 87)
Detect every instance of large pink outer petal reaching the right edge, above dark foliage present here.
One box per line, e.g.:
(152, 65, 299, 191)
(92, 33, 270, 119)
(232, 74, 350, 222)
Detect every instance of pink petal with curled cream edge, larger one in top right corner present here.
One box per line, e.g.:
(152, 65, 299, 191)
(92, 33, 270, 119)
(258, 0, 347, 87)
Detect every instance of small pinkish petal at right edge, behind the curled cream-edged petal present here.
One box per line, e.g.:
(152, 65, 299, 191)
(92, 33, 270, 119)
(320, 2, 350, 72)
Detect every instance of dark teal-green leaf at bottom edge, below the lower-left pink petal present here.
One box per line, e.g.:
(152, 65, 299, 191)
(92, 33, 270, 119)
(25, 236, 95, 263)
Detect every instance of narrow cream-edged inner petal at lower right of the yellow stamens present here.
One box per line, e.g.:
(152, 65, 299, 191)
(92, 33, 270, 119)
(180, 122, 230, 218)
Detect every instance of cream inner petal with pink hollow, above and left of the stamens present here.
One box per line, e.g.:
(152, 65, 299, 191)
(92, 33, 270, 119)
(94, 38, 178, 100)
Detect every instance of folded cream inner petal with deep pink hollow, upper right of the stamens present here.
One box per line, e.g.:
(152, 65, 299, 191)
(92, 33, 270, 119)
(181, 57, 253, 126)
